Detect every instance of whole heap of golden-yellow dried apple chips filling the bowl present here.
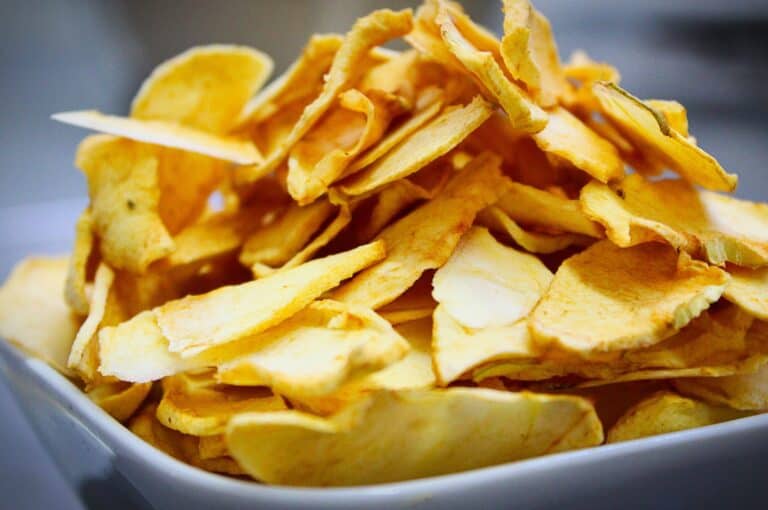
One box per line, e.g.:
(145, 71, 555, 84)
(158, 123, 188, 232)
(0, 0, 768, 485)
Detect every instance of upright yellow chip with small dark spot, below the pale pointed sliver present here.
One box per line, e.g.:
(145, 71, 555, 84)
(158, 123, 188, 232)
(76, 135, 174, 273)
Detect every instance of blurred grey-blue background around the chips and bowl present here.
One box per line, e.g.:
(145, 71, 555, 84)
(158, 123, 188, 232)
(0, 0, 768, 510)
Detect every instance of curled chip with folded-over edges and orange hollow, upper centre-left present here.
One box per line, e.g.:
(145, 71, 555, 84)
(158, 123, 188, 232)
(286, 89, 405, 205)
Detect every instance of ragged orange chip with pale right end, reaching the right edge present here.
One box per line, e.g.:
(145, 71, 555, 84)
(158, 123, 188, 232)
(581, 174, 768, 267)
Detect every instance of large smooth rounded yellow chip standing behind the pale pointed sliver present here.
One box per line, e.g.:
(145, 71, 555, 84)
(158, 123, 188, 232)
(131, 44, 273, 133)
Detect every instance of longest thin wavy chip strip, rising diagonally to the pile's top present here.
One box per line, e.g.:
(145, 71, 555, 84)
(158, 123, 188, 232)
(238, 9, 412, 183)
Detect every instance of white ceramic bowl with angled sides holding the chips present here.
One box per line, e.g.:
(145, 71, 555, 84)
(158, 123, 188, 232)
(0, 341, 768, 510)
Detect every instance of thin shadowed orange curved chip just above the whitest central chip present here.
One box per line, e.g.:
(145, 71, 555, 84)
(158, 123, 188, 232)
(477, 206, 592, 254)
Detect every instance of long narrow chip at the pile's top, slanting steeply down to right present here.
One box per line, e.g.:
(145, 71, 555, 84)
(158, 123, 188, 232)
(436, 4, 547, 133)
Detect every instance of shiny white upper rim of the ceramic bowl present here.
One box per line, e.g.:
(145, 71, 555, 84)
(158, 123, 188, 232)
(0, 339, 768, 504)
